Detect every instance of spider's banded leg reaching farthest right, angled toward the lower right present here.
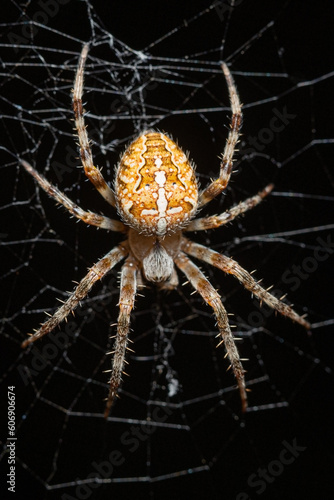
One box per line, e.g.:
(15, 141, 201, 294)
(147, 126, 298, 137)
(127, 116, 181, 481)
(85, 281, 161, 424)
(181, 238, 311, 330)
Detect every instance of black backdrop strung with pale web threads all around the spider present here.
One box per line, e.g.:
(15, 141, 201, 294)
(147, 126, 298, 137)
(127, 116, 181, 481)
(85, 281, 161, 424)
(0, 0, 334, 500)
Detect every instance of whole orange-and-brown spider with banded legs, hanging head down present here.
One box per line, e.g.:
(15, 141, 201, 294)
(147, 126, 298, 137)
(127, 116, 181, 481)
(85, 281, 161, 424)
(21, 44, 310, 418)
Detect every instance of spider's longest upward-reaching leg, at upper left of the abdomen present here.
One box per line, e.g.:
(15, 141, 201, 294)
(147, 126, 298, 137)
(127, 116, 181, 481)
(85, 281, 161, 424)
(72, 44, 116, 207)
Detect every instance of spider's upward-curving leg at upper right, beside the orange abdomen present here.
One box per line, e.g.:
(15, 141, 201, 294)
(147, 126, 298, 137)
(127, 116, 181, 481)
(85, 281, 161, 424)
(198, 63, 242, 208)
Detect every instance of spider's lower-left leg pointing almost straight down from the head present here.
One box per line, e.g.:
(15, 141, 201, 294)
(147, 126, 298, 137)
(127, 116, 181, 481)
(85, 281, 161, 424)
(104, 257, 138, 418)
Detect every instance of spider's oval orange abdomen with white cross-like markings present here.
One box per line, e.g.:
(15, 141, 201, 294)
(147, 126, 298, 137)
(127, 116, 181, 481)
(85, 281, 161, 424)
(115, 131, 198, 236)
